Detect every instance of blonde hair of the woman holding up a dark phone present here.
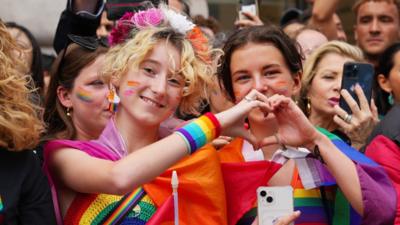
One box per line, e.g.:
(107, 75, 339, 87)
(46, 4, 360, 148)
(299, 41, 365, 116)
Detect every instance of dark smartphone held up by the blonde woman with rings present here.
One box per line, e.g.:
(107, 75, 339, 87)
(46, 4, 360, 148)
(339, 62, 374, 114)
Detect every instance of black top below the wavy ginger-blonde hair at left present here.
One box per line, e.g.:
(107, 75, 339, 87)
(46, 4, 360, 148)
(0, 148, 56, 225)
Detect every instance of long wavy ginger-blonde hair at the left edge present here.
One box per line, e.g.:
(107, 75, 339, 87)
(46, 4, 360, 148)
(0, 21, 44, 151)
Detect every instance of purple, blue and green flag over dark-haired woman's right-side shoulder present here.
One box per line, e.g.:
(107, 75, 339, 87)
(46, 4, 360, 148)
(314, 127, 396, 225)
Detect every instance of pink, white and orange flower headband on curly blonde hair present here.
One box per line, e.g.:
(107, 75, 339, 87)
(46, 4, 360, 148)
(108, 7, 209, 62)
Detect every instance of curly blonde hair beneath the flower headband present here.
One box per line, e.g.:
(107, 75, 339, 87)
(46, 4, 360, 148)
(103, 27, 214, 115)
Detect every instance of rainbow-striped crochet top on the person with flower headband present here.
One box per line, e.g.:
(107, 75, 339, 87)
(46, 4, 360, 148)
(64, 188, 156, 225)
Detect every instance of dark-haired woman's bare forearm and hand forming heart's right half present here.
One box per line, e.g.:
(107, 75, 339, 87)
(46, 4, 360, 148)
(262, 95, 364, 215)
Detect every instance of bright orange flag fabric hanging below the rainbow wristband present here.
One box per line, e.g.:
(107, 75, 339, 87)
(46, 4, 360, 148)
(144, 146, 227, 225)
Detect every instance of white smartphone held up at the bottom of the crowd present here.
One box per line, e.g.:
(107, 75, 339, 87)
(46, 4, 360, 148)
(257, 186, 293, 225)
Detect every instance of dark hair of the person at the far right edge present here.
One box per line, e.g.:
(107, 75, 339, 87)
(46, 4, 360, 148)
(373, 42, 400, 115)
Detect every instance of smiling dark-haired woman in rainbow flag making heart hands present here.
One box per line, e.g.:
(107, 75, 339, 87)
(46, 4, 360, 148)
(214, 26, 396, 224)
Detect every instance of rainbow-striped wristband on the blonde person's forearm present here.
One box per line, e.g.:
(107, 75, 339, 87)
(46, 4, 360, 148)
(175, 113, 221, 154)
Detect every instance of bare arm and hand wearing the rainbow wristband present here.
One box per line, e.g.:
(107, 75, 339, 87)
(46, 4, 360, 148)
(49, 89, 265, 194)
